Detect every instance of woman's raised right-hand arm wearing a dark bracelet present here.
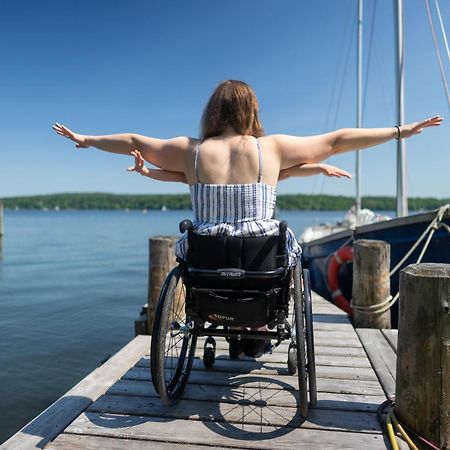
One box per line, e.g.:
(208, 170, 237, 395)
(272, 116, 443, 169)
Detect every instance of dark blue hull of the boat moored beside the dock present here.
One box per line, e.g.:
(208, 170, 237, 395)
(302, 206, 450, 325)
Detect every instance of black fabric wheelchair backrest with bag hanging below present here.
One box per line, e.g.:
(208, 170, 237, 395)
(184, 224, 289, 327)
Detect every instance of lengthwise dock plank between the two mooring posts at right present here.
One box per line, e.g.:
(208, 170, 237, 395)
(356, 328, 396, 397)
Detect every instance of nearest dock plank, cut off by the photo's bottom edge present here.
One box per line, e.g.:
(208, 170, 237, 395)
(45, 433, 229, 450)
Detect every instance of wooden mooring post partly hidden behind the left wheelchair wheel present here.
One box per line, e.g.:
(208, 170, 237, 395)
(147, 236, 178, 334)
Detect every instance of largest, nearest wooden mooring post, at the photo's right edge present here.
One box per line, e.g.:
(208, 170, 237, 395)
(395, 264, 450, 449)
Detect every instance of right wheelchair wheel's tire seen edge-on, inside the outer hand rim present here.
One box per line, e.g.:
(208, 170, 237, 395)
(292, 264, 308, 417)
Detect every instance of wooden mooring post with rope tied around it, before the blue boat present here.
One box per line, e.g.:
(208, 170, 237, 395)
(352, 239, 391, 328)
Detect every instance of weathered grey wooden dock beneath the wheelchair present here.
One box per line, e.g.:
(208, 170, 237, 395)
(0, 296, 407, 450)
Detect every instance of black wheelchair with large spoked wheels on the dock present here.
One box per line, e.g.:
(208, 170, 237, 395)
(150, 220, 317, 417)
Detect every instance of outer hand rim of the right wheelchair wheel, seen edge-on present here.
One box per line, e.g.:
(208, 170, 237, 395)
(303, 269, 317, 408)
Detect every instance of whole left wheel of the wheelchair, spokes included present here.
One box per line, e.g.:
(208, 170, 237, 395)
(150, 267, 197, 405)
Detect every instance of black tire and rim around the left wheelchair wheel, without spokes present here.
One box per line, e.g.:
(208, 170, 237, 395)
(150, 267, 197, 405)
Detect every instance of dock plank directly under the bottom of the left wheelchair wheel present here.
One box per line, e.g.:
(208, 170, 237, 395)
(106, 380, 386, 412)
